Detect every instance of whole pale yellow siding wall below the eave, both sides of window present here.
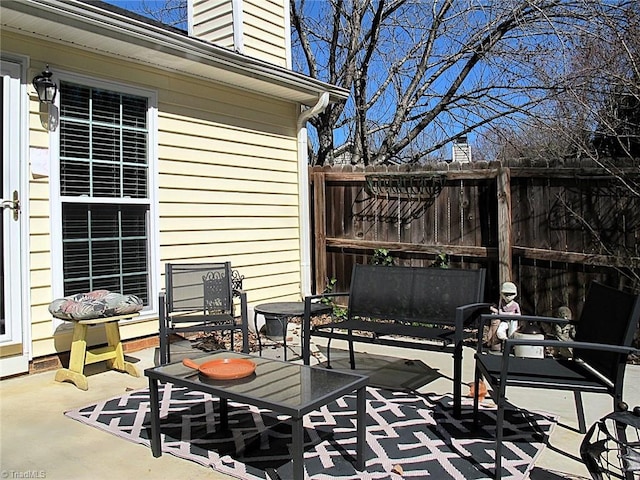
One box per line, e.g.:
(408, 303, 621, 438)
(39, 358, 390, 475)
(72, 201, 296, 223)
(2, 33, 301, 357)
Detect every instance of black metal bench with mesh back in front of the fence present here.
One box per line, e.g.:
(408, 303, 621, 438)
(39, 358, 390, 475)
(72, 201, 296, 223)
(303, 265, 490, 416)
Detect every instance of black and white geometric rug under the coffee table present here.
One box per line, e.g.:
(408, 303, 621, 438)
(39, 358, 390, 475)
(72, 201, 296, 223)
(65, 384, 555, 480)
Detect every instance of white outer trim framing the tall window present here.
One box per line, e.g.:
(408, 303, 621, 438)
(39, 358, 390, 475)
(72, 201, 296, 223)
(49, 69, 160, 332)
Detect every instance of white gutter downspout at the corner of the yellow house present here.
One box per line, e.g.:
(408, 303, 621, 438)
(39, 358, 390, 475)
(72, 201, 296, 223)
(297, 92, 329, 297)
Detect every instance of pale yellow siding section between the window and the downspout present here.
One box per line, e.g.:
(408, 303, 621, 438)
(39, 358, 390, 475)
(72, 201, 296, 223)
(158, 70, 300, 304)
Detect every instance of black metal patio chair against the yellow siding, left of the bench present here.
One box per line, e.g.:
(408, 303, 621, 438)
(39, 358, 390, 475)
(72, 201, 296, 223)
(158, 262, 249, 365)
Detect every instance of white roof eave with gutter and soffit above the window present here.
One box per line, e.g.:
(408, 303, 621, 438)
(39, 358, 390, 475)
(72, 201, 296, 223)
(0, 0, 349, 106)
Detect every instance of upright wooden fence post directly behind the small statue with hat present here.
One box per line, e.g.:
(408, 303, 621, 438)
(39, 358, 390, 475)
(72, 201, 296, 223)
(496, 167, 513, 284)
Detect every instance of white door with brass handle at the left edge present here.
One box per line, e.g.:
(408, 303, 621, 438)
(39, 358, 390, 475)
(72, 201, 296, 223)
(0, 60, 29, 377)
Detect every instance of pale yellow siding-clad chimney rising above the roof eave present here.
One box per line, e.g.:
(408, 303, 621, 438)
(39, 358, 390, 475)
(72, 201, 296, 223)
(187, 0, 291, 69)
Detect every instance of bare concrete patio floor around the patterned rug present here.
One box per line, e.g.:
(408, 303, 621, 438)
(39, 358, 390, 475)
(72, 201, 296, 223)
(0, 339, 640, 480)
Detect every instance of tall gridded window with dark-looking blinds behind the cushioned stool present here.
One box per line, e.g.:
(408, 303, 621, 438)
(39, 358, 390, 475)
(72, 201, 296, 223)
(59, 82, 151, 304)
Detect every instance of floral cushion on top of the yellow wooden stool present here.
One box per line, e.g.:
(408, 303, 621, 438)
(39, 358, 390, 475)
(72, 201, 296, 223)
(49, 290, 144, 320)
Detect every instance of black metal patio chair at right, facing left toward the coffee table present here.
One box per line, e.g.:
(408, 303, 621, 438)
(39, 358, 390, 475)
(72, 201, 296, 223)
(473, 282, 640, 479)
